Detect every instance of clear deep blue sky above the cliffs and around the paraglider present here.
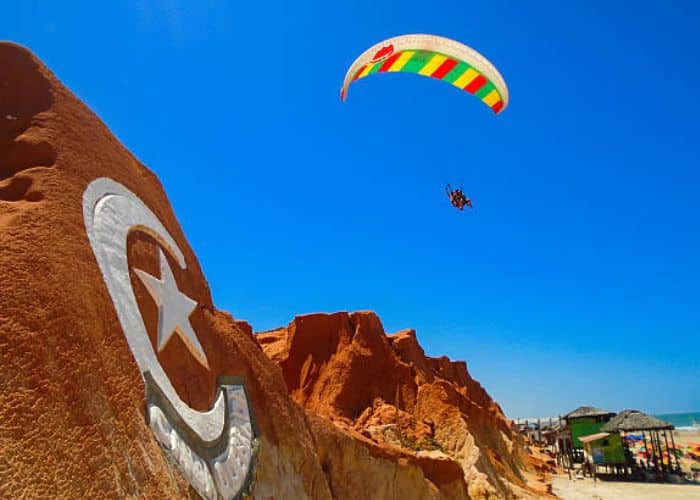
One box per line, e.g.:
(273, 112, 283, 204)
(6, 0, 700, 417)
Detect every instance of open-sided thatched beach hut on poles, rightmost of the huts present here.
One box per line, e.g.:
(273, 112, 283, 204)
(601, 410, 680, 472)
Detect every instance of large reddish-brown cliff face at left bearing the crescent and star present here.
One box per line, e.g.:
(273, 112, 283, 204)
(0, 43, 331, 498)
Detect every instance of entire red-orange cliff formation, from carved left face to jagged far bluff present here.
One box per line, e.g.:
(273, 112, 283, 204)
(0, 43, 548, 499)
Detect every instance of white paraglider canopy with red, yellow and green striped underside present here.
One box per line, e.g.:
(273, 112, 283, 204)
(340, 35, 508, 114)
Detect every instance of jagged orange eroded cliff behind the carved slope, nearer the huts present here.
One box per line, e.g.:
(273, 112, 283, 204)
(257, 312, 547, 498)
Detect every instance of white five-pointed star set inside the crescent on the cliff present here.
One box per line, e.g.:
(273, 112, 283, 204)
(134, 249, 209, 370)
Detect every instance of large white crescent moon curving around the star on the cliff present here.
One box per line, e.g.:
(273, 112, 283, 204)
(83, 178, 226, 443)
